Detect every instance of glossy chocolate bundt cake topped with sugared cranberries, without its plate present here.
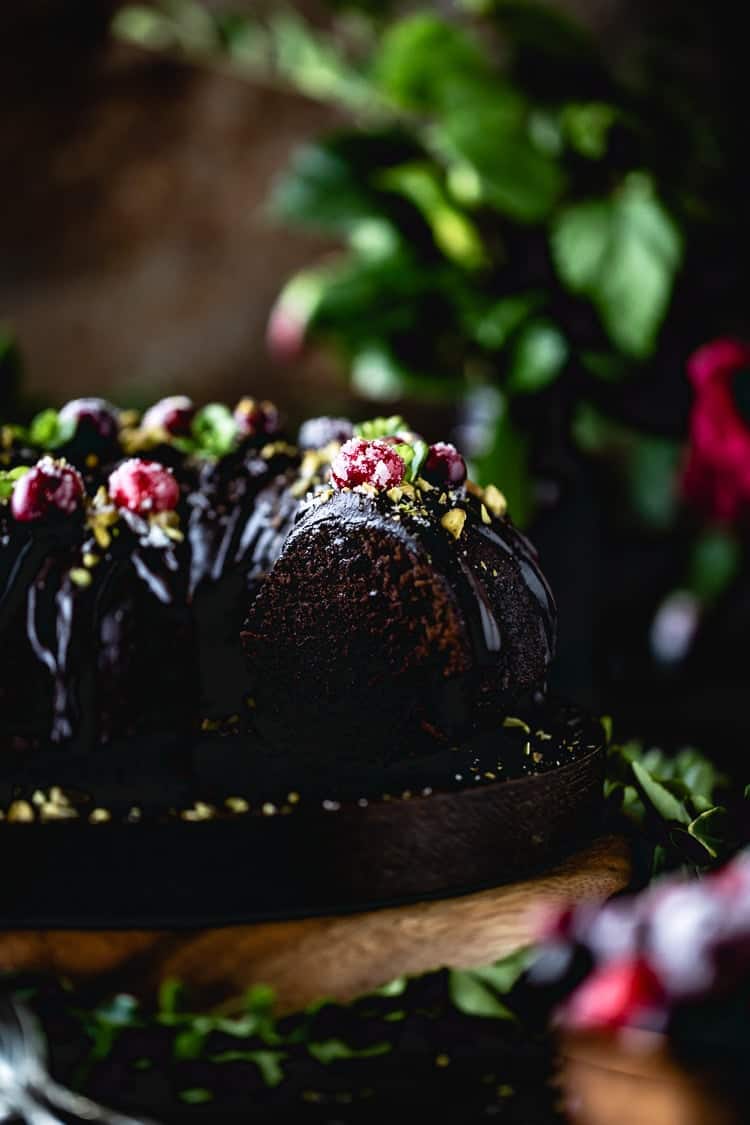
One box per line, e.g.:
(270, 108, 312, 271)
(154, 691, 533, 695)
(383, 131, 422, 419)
(0, 396, 555, 767)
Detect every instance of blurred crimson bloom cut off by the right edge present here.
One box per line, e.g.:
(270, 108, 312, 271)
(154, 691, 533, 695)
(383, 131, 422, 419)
(683, 339, 750, 523)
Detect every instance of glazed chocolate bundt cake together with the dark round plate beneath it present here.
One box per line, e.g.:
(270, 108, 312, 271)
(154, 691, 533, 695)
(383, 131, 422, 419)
(0, 396, 604, 928)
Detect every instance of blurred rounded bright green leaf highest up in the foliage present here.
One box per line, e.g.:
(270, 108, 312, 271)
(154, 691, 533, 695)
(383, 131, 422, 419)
(373, 12, 491, 113)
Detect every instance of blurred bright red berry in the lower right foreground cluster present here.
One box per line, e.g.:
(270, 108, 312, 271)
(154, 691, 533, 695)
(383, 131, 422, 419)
(562, 957, 665, 1031)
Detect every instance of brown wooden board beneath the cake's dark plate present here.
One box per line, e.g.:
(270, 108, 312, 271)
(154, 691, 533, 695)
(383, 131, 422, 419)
(0, 836, 631, 1011)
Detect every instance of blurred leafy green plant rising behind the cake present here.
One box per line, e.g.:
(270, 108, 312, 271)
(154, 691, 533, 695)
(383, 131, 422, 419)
(108, 0, 693, 524)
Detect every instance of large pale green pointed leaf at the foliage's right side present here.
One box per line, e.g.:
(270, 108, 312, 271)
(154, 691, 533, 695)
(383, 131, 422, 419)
(552, 173, 681, 359)
